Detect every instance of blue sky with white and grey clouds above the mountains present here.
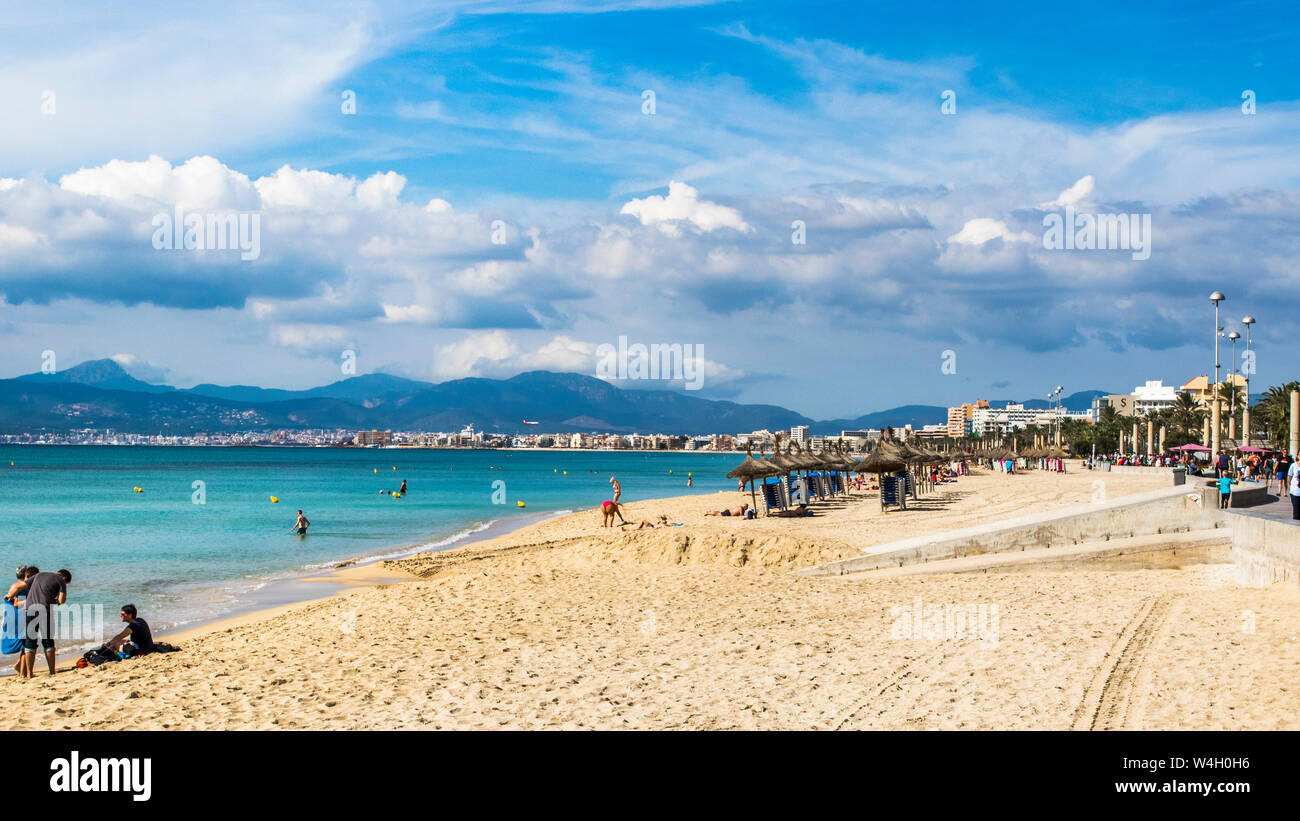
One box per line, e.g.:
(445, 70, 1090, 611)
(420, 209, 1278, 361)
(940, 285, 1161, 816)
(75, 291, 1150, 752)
(0, 0, 1300, 418)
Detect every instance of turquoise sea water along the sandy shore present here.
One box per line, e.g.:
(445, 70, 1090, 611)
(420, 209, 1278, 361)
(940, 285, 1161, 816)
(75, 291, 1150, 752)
(0, 446, 740, 639)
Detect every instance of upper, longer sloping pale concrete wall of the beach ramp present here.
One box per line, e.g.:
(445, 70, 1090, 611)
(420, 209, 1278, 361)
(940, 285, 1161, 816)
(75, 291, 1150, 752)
(798, 474, 1226, 575)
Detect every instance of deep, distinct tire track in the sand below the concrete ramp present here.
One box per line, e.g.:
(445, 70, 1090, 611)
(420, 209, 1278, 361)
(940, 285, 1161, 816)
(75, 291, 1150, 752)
(1070, 594, 1177, 730)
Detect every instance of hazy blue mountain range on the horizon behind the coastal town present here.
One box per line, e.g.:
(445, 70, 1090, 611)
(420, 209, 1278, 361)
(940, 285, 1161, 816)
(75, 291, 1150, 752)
(0, 359, 1105, 435)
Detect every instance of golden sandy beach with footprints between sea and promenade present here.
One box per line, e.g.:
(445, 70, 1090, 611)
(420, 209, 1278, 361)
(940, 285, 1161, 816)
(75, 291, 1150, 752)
(0, 472, 1300, 729)
